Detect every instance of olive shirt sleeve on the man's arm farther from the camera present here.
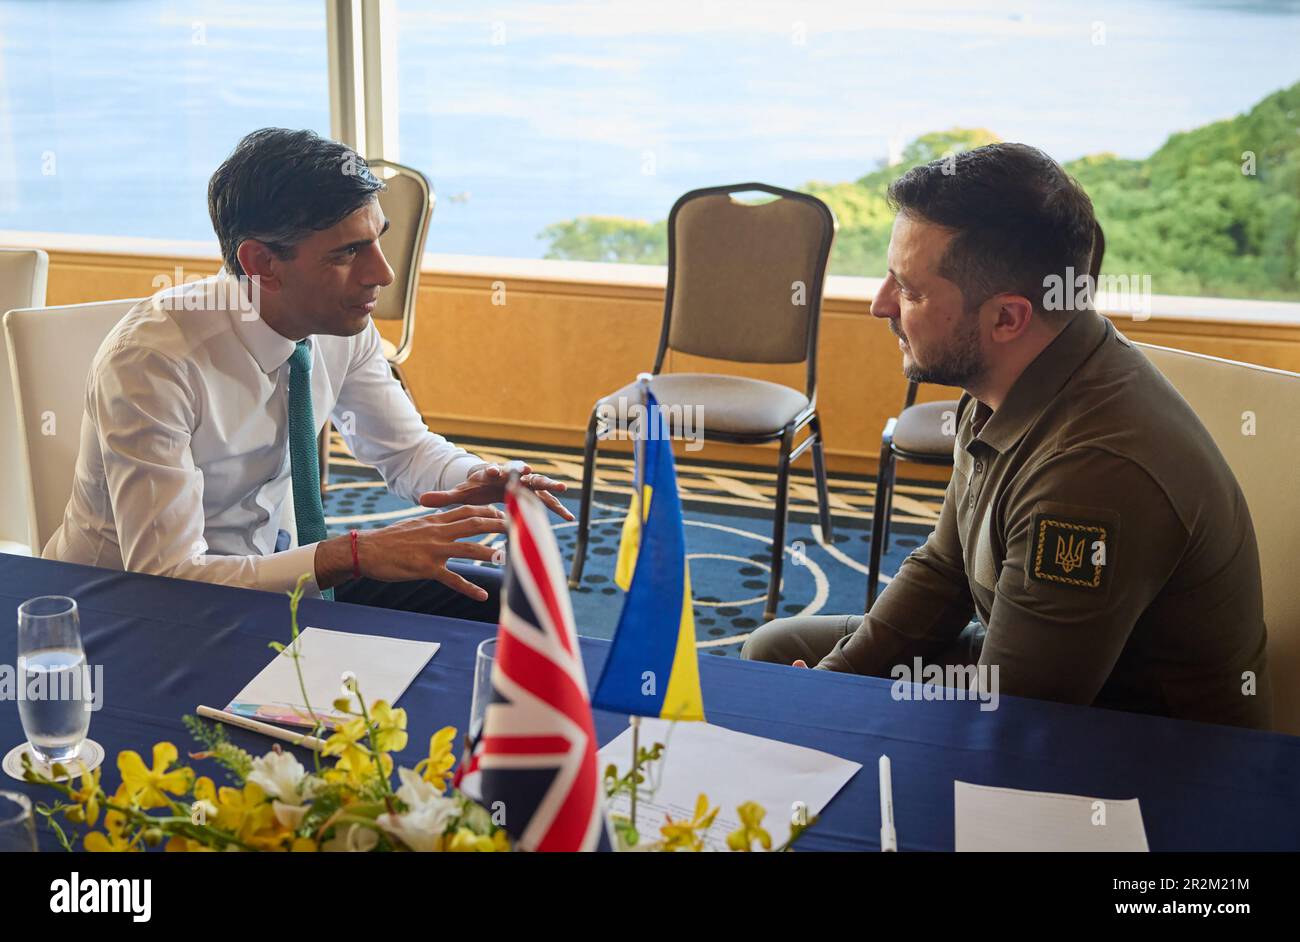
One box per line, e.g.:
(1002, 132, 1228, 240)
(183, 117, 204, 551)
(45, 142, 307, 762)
(816, 474, 975, 676)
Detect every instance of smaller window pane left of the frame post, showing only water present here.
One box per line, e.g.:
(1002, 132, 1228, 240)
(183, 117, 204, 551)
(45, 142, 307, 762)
(0, 0, 330, 240)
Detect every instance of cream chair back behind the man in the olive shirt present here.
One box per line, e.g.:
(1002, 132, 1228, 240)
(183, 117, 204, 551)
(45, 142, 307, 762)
(1134, 343, 1300, 735)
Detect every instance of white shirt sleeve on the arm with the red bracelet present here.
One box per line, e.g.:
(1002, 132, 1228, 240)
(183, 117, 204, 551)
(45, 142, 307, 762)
(87, 346, 319, 592)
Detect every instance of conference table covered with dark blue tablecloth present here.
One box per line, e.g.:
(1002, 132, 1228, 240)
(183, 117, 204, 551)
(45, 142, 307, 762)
(0, 554, 1300, 851)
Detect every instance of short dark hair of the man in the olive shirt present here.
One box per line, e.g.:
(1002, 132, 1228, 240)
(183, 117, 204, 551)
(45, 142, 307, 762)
(888, 144, 1097, 320)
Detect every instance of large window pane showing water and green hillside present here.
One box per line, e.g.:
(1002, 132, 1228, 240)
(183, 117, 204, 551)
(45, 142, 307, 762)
(398, 0, 1300, 299)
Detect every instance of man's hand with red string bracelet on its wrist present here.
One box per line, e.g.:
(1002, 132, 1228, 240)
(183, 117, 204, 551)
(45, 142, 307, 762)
(316, 505, 506, 602)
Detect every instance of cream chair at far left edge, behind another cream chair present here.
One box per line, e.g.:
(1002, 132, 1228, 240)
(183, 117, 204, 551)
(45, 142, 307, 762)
(0, 248, 49, 556)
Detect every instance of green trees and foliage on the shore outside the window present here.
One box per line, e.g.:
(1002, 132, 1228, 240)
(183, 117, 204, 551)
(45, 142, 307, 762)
(540, 83, 1300, 300)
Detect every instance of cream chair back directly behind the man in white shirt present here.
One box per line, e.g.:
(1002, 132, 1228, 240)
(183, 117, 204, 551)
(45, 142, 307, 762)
(4, 299, 139, 556)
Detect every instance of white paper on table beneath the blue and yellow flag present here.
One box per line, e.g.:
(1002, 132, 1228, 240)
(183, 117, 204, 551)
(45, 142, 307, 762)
(599, 719, 862, 851)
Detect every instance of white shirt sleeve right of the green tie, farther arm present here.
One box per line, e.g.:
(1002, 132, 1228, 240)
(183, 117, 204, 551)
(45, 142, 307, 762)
(332, 322, 485, 502)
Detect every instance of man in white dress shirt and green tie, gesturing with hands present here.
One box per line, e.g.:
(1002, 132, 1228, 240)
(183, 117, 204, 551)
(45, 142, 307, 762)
(44, 129, 573, 621)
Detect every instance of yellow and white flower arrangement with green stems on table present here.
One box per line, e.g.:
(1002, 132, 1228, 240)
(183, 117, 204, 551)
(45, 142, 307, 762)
(23, 576, 815, 851)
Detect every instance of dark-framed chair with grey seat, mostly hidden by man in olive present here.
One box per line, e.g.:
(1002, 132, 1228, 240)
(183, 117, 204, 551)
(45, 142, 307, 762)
(863, 222, 1106, 611)
